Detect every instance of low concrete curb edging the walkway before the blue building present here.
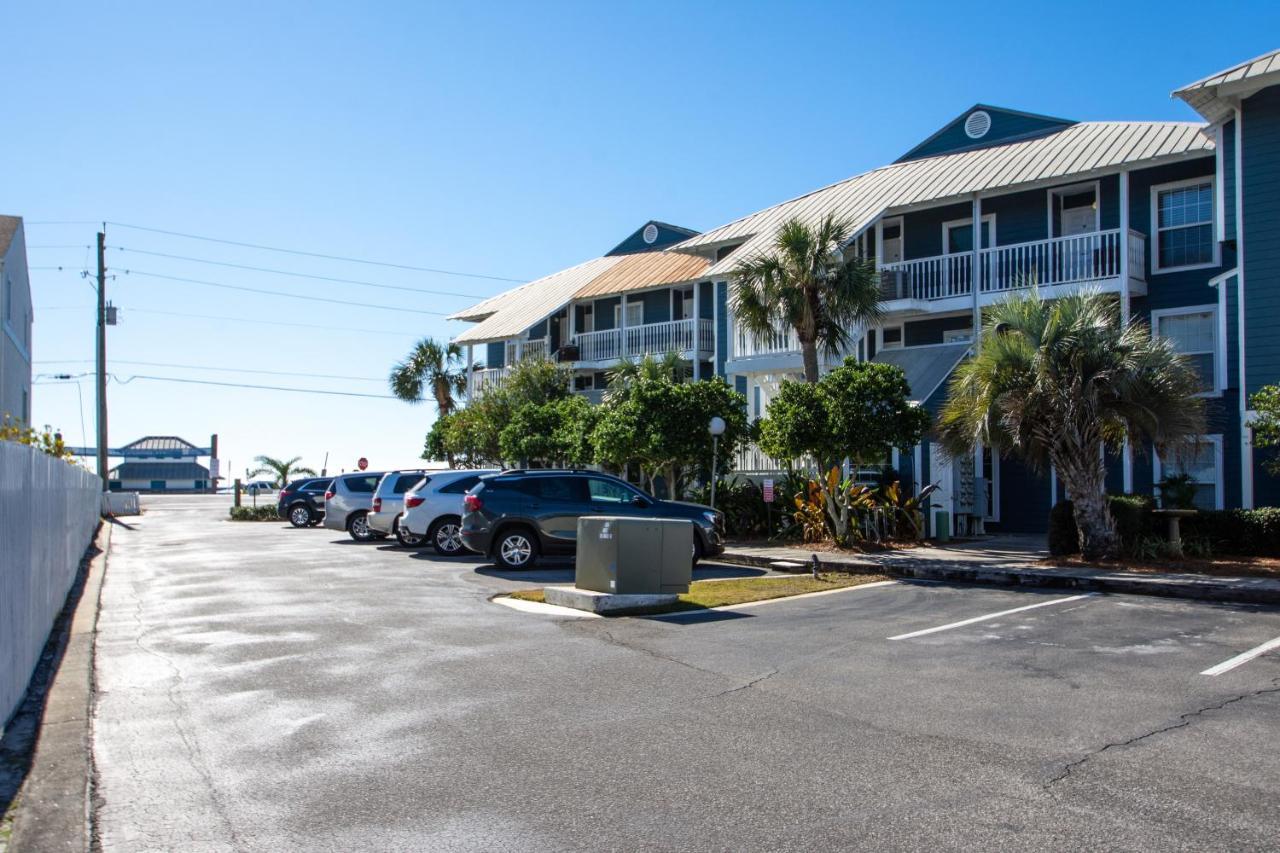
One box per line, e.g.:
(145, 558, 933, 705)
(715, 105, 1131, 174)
(717, 551, 1280, 605)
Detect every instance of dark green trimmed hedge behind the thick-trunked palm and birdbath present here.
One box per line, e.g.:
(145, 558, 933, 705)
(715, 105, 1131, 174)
(1048, 494, 1280, 557)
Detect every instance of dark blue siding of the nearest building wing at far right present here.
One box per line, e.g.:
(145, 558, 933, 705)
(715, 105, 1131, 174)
(1240, 86, 1280, 399)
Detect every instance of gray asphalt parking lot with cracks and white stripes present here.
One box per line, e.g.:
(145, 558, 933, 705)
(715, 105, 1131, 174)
(95, 496, 1280, 850)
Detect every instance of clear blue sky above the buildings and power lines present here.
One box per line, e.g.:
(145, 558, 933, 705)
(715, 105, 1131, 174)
(12, 1, 1280, 474)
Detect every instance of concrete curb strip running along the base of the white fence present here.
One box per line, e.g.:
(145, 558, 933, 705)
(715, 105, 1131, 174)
(10, 519, 115, 853)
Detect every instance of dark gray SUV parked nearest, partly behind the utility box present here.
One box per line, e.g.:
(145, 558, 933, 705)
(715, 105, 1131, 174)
(462, 470, 724, 569)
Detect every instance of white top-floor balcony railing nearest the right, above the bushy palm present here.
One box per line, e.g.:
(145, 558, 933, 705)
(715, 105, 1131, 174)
(881, 229, 1147, 300)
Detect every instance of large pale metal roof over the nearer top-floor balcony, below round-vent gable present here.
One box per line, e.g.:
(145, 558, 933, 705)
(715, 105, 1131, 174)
(668, 122, 1213, 275)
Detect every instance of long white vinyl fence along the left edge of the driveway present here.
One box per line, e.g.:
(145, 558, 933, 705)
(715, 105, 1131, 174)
(0, 441, 102, 729)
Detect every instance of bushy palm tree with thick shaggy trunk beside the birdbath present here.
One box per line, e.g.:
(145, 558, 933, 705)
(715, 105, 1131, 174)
(938, 288, 1204, 560)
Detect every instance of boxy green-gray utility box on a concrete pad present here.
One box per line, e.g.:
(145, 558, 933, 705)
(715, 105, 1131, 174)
(573, 515, 694, 596)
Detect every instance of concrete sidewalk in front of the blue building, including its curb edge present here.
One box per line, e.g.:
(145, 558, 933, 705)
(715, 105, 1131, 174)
(719, 535, 1280, 605)
